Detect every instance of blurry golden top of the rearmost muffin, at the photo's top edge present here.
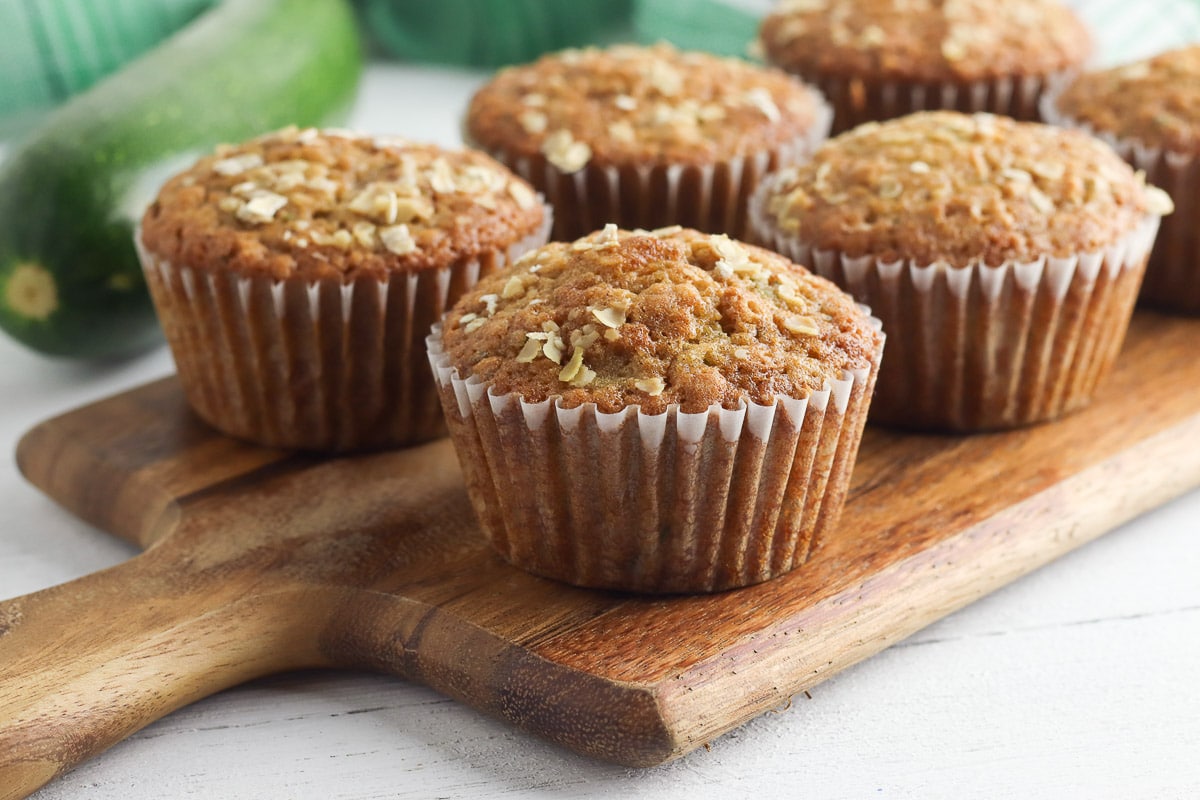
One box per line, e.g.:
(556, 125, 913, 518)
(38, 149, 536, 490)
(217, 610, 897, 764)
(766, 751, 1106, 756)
(758, 0, 1092, 83)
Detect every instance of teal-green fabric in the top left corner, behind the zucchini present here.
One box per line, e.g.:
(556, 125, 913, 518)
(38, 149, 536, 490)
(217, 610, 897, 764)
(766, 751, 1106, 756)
(0, 0, 214, 134)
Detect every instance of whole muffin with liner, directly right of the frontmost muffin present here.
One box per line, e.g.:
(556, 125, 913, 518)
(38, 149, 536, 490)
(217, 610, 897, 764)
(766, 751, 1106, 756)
(751, 112, 1170, 431)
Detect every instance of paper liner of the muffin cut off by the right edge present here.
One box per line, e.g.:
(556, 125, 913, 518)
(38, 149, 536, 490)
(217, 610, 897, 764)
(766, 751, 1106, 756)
(1040, 88, 1200, 314)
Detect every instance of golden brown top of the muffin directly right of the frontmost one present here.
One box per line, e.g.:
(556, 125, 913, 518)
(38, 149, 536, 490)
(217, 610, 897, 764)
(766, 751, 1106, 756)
(760, 112, 1171, 266)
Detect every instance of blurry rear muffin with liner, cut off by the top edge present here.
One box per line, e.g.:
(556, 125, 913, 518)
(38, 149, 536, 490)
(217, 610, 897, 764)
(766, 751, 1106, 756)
(760, 0, 1092, 133)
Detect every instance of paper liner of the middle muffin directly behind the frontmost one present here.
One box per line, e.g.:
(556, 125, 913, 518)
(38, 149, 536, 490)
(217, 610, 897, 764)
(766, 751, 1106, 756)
(464, 98, 833, 241)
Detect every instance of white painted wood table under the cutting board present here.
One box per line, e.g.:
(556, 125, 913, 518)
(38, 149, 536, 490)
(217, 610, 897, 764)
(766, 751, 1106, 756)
(0, 66, 1200, 800)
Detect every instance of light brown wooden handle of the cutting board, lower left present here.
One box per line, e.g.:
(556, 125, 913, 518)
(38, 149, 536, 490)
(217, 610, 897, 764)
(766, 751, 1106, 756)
(0, 537, 323, 800)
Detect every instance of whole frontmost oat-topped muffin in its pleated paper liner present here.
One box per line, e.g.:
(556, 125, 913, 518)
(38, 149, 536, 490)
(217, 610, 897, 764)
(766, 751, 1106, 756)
(428, 225, 883, 593)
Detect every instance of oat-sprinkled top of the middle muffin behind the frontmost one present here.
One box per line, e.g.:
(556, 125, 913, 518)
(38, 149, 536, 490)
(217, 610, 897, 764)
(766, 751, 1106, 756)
(467, 44, 828, 173)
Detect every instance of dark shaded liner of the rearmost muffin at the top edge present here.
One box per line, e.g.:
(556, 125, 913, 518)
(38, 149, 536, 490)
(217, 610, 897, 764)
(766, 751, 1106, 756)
(775, 65, 1069, 136)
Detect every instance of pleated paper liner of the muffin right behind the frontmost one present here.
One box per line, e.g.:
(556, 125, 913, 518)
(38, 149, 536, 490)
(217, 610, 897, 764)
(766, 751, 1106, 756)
(751, 187, 1159, 432)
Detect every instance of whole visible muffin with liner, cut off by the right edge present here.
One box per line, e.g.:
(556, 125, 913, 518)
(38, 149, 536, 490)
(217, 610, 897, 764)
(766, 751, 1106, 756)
(1042, 44, 1200, 314)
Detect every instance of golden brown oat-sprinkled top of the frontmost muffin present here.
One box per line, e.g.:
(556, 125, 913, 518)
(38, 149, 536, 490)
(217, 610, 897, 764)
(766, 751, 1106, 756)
(443, 225, 882, 414)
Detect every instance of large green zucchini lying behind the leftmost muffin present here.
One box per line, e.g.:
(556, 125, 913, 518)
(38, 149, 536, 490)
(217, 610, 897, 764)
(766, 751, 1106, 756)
(0, 0, 361, 359)
